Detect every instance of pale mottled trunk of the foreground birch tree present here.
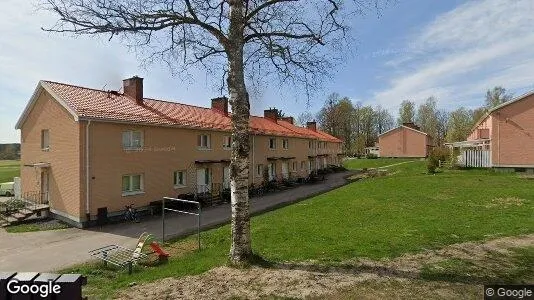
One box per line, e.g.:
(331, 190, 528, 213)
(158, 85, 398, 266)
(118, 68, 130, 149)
(227, 0, 252, 266)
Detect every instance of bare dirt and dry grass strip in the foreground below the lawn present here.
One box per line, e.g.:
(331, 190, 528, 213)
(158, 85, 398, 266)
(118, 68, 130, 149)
(119, 234, 534, 299)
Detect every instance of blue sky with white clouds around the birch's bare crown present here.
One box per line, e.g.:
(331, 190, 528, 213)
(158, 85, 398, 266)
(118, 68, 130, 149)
(0, 0, 534, 143)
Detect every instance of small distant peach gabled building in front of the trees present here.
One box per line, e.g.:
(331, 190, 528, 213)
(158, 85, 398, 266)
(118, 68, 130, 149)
(378, 123, 434, 157)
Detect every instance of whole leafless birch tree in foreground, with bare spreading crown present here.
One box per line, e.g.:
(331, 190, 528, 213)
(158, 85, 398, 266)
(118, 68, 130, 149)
(41, 0, 386, 265)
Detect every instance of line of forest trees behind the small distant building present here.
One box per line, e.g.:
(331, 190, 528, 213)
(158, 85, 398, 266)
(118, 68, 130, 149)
(308, 86, 512, 154)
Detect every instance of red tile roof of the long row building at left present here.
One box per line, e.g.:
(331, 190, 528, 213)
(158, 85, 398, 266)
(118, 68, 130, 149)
(44, 81, 341, 142)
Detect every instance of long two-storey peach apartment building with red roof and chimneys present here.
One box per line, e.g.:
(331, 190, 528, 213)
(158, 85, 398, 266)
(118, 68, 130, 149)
(16, 77, 342, 227)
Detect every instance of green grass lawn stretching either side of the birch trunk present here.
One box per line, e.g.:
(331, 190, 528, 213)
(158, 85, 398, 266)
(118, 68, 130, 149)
(68, 159, 534, 298)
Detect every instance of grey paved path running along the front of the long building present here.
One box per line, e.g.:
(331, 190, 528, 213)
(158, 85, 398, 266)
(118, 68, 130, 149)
(0, 172, 352, 272)
